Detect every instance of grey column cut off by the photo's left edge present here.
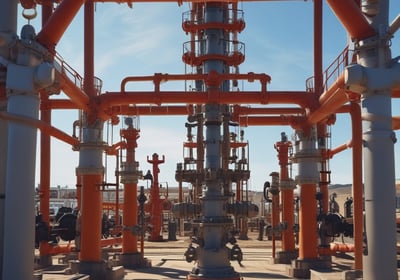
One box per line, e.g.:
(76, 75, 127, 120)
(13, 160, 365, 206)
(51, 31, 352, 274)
(0, 0, 19, 279)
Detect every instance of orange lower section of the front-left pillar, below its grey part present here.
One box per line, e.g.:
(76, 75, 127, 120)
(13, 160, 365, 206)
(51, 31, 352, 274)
(79, 174, 103, 262)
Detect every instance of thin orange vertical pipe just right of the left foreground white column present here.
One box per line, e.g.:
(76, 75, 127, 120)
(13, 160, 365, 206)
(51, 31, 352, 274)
(39, 94, 51, 256)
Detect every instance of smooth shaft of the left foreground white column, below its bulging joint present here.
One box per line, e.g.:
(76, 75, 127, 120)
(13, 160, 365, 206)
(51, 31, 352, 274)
(2, 93, 39, 279)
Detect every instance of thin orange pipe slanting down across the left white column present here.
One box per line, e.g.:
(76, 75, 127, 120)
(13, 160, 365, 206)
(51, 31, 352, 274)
(0, 112, 79, 146)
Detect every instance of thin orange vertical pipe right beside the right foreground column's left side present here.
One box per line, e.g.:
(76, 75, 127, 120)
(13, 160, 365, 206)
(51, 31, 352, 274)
(350, 102, 364, 270)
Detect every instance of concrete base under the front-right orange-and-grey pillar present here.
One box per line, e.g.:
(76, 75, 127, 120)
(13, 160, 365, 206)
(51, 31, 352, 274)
(287, 258, 332, 279)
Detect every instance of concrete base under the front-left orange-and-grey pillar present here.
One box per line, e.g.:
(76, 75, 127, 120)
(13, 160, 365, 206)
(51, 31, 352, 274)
(69, 261, 125, 280)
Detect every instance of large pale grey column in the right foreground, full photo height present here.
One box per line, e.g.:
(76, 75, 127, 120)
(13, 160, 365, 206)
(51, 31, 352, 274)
(358, 0, 398, 280)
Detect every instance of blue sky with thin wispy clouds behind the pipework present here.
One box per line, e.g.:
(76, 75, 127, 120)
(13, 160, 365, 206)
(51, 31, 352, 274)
(14, 0, 400, 190)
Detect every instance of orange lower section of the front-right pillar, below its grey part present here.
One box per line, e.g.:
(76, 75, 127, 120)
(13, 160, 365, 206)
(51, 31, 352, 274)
(299, 184, 318, 260)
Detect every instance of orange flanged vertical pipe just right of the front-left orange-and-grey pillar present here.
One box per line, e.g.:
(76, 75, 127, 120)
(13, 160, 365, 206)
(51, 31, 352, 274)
(121, 125, 139, 254)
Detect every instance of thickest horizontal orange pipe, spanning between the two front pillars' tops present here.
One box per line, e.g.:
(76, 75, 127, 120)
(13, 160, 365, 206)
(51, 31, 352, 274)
(98, 91, 309, 107)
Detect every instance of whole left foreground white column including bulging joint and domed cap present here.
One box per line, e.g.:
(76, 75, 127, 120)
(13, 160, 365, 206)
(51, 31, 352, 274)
(2, 25, 54, 279)
